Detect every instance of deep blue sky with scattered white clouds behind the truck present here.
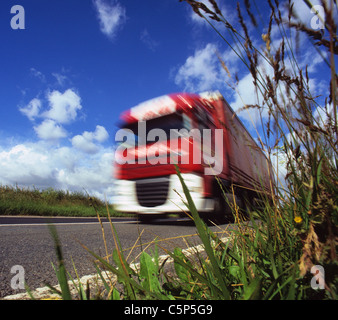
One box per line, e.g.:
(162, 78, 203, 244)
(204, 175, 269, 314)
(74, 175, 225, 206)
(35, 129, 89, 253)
(0, 0, 327, 197)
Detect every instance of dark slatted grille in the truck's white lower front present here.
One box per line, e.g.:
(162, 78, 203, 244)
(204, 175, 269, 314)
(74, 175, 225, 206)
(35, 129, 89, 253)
(136, 177, 169, 207)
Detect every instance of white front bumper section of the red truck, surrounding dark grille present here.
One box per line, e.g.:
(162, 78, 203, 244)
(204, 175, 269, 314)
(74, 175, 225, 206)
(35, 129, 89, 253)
(113, 174, 214, 215)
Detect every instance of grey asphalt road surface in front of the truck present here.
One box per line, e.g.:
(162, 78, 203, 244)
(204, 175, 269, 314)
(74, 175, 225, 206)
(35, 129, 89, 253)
(0, 216, 231, 299)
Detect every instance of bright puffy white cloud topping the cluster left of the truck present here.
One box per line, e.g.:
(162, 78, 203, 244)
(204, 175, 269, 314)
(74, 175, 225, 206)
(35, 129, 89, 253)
(42, 89, 82, 123)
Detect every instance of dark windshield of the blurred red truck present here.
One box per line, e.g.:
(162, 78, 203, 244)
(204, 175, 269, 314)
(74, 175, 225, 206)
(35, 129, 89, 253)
(118, 113, 191, 147)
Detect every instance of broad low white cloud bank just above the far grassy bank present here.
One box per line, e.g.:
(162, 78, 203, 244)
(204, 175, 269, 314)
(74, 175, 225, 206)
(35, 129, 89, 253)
(0, 142, 113, 201)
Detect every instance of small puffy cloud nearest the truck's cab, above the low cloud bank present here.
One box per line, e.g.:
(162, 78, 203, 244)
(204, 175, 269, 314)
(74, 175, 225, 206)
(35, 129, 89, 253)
(71, 125, 109, 154)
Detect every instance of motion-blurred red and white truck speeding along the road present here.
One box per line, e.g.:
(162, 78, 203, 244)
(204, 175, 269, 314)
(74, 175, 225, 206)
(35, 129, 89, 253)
(114, 92, 272, 219)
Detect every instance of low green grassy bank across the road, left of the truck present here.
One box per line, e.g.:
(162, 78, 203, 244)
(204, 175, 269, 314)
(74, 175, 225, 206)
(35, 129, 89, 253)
(0, 186, 123, 217)
